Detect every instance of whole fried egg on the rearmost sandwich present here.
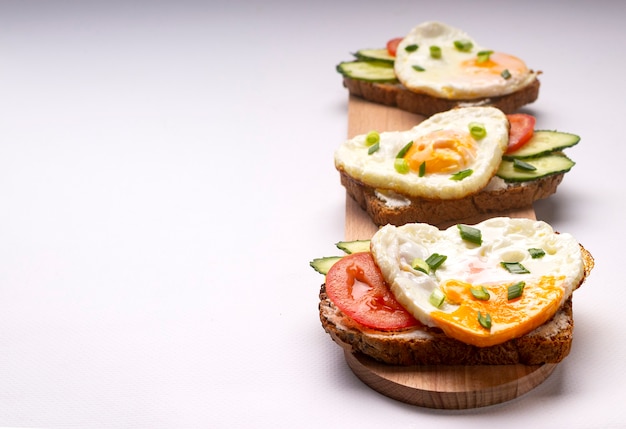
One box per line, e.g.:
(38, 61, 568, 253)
(394, 22, 536, 100)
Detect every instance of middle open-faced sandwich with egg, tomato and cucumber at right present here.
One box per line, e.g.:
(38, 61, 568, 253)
(334, 107, 580, 226)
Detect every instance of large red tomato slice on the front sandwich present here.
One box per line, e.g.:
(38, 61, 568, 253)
(326, 252, 419, 330)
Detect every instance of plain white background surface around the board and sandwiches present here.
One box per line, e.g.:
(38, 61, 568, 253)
(0, 0, 626, 428)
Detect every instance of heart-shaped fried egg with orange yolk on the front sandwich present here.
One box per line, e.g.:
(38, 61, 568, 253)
(371, 217, 584, 347)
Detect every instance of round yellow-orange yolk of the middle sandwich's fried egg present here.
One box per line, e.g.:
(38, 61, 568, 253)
(404, 130, 476, 174)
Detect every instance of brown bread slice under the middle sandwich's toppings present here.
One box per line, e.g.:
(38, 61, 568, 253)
(339, 170, 565, 226)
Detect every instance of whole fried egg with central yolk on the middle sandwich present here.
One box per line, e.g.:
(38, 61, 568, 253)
(335, 107, 509, 199)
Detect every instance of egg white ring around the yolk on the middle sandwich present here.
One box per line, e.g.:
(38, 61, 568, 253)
(335, 107, 509, 199)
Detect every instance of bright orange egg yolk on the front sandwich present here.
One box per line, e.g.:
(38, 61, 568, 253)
(431, 276, 565, 347)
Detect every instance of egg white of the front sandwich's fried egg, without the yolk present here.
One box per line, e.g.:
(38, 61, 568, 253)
(371, 217, 584, 326)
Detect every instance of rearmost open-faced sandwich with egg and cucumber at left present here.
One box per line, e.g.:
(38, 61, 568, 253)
(337, 22, 540, 116)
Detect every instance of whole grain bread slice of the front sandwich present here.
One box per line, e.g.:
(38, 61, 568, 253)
(319, 246, 594, 365)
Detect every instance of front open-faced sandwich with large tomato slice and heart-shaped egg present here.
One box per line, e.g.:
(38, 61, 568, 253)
(311, 217, 594, 365)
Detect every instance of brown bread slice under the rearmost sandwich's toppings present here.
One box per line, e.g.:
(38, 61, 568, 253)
(343, 73, 541, 116)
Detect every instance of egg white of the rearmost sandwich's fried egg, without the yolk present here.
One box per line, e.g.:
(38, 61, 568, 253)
(394, 22, 536, 100)
